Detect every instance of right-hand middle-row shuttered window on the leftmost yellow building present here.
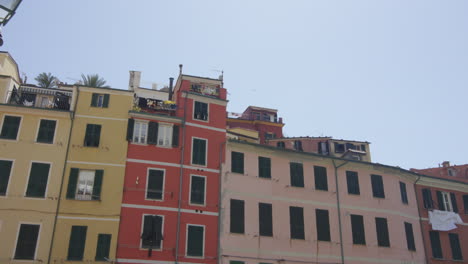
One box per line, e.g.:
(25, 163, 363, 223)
(26, 162, 50, 198)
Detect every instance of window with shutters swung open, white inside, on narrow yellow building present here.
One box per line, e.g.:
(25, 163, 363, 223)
(67, 168, 104, 200)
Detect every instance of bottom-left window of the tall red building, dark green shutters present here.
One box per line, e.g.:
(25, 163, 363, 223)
(141, 215, 164, 249)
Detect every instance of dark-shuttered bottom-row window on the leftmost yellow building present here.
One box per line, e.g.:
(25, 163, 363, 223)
(15, 224, 40, 260)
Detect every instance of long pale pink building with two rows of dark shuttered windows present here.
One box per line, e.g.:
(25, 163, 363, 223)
(219, 140, 425, 264)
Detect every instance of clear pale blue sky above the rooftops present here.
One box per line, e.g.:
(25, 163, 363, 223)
(1, 0, 468, 168)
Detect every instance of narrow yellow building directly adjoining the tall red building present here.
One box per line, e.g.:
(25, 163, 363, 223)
(49, 86, 133, 263)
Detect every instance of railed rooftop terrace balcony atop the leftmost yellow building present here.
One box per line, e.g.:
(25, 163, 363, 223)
(7, 86, 73, 111)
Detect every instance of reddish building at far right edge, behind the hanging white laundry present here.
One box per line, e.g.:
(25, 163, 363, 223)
(411, 161, 468, 264)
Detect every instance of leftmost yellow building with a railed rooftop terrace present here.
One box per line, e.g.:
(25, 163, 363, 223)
(0, 52, 74, 263)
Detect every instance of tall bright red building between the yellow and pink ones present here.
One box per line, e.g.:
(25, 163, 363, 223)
(117, 72, 227, 264)
